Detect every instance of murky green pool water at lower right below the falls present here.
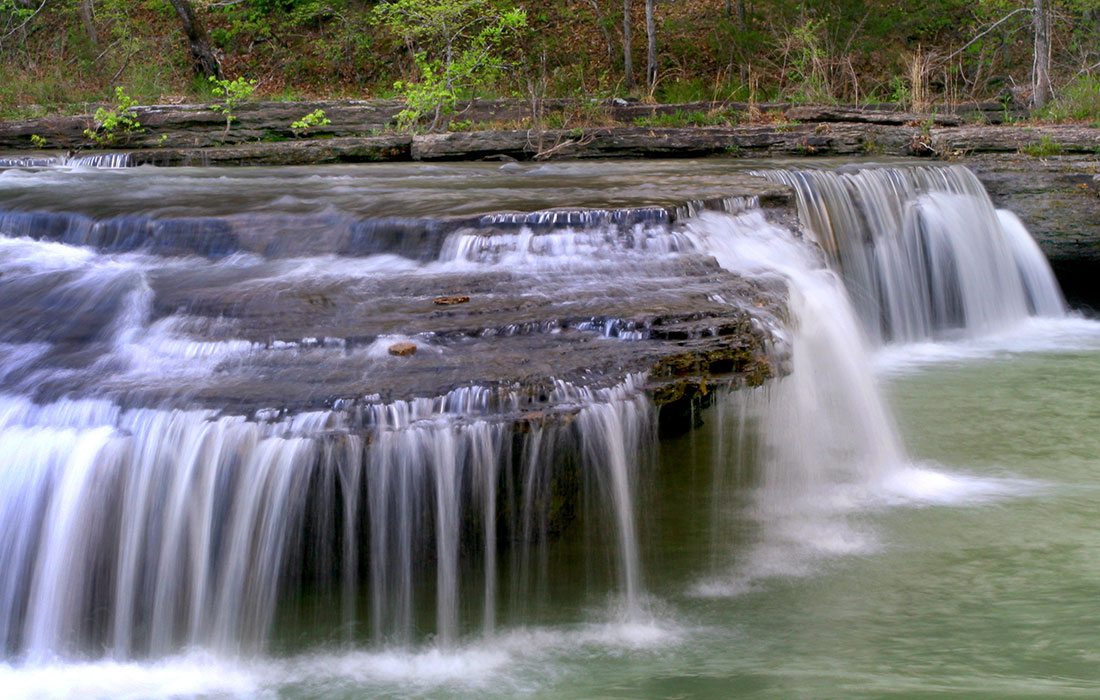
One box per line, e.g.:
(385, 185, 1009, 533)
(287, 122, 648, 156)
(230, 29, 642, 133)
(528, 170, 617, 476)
(546, 345, 1100, 698)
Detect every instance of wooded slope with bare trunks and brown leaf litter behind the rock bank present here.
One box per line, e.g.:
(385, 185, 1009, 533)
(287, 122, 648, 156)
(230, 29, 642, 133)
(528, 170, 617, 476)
(0, 0, 1100, 125)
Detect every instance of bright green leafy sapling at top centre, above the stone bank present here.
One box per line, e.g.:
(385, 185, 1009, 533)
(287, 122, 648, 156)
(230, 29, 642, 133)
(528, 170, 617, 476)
(374, 0, 527, 129)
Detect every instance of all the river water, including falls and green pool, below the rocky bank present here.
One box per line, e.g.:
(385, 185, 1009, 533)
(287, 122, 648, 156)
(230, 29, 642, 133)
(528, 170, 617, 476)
(0, 161, 1100, 698)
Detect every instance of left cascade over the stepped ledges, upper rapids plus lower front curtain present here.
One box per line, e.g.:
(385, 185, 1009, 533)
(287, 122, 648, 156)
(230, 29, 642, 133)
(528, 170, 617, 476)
(0, 175, 686, 663)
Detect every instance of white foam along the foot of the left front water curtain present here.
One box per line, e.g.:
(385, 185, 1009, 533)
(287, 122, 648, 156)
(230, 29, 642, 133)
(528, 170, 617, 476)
(0, 616, 690, 700)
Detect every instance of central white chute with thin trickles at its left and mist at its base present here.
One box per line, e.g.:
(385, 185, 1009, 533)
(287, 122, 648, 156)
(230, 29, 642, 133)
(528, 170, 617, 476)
(688, 211, 906, 597)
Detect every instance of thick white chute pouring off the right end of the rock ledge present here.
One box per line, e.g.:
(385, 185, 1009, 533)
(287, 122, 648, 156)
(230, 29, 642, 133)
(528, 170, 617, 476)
(685, 209, 904, 495)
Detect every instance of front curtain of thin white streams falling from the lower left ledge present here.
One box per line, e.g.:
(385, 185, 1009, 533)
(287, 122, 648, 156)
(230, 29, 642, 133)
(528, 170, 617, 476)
(0, 378, 651, 659)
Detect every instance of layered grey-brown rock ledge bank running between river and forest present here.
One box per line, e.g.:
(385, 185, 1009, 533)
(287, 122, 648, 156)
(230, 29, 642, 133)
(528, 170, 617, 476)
(0, 100, 1100, 160)
